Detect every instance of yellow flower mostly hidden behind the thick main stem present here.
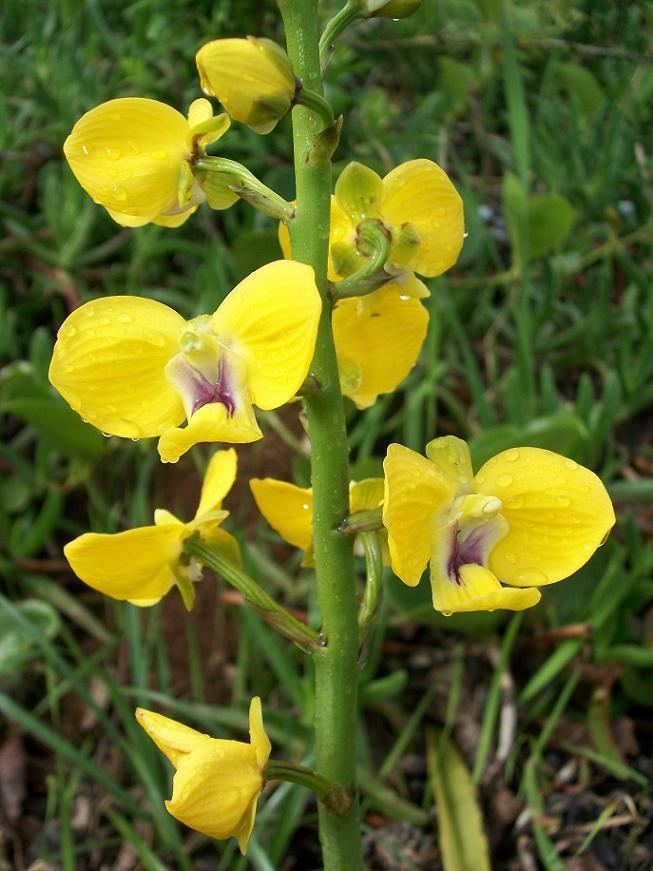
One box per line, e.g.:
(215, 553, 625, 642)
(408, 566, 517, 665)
(249, 478, 384, 567)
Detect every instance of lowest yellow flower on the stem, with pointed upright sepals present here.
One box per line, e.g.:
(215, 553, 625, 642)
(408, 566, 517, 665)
(136, 696, 271, 854)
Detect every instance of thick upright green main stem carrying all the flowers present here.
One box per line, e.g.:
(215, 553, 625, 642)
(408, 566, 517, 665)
(277, 0, 363, 871)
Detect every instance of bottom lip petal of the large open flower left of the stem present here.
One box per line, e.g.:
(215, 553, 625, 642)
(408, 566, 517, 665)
(158, 401, 263, 463)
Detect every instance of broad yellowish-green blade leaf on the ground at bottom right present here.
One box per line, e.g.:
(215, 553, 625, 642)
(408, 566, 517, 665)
(426, 729, 490, 871)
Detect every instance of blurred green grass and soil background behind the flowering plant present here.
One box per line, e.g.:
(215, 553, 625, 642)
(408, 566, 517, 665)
(0, 0, 653, 871)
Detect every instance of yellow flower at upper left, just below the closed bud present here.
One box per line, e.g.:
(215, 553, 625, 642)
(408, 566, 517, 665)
(63, 97, 232, 227)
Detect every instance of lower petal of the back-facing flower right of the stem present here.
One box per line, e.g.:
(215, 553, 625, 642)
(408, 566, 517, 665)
(333, 284, 429, 408)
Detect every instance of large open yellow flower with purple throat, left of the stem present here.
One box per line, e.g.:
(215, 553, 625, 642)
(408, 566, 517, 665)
(49, 260, 322, 463)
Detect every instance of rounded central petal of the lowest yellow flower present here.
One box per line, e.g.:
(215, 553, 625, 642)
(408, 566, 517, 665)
(166, 738, 263, 839)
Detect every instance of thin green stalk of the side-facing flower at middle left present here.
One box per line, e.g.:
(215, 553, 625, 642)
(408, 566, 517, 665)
(184, 536, 321, 653)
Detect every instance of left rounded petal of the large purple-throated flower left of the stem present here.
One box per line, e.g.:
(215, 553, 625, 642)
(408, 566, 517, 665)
(49, 296, 184, 438)
